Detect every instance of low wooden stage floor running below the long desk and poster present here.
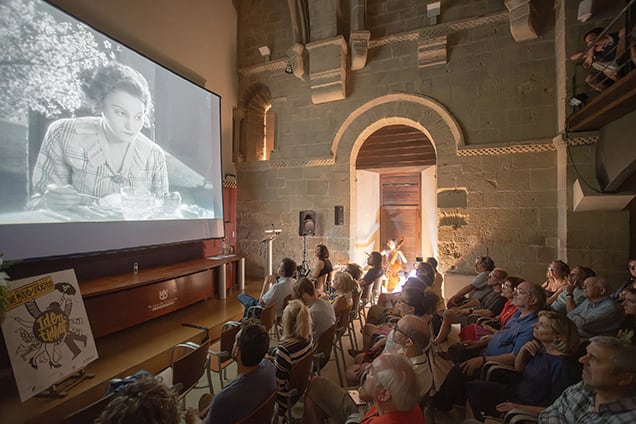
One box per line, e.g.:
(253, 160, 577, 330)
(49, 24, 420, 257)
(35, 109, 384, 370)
(0, 279, 262, 424)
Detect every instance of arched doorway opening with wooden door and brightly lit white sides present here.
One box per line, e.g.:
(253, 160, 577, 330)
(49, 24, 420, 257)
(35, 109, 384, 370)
(355, 123, 437, 263)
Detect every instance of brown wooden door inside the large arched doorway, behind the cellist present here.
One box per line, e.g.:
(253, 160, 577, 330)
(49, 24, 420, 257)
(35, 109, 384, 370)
(380, 172, 422, 264)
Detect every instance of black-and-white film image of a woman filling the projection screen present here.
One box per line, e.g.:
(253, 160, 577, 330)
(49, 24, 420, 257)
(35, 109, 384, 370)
(0, 0, 222, 225)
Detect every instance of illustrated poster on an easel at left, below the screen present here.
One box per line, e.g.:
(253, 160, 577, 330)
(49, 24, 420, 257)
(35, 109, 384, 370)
(2, 269, 97, 402)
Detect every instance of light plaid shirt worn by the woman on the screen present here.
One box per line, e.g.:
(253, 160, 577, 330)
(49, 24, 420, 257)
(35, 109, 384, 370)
(28, 117, 168, 208)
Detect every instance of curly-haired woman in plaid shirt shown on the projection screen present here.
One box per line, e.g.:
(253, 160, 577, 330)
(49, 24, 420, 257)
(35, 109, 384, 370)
(27, 62, 168, 209)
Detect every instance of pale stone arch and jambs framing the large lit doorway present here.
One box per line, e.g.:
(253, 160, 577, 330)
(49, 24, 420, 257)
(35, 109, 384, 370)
(331, 94, 464, 260)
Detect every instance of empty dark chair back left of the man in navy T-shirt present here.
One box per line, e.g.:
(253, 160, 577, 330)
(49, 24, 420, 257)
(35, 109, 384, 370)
(170, 340, 210, 398)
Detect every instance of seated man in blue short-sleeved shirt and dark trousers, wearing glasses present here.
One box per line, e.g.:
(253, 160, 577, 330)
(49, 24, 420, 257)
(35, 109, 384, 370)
(433, 281, 545, 411)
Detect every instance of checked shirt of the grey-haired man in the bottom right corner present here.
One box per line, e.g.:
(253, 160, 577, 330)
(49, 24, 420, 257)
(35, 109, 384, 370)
(539, 381, 636, 424)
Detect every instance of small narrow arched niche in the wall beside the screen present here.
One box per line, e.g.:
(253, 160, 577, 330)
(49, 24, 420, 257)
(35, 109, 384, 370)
(234, 84, 274, 162)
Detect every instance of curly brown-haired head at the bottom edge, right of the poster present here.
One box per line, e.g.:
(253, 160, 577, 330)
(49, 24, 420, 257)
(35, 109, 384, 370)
(95, 375, 181, 424)
